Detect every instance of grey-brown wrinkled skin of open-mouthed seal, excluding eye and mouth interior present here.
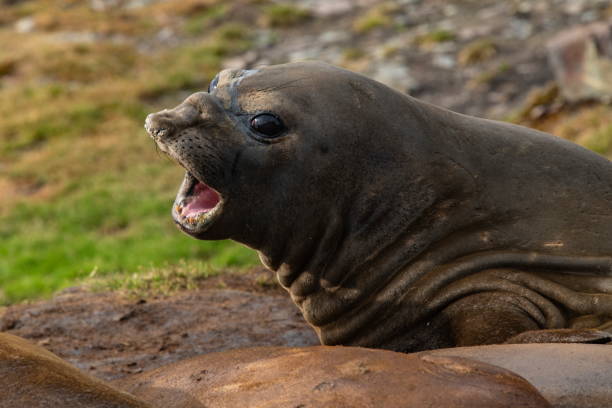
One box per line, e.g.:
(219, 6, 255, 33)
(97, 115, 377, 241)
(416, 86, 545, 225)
(146, 62, 612, 351)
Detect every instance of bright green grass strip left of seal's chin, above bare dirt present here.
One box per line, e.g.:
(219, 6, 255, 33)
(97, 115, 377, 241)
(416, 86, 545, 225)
(0, 167, 257, 303)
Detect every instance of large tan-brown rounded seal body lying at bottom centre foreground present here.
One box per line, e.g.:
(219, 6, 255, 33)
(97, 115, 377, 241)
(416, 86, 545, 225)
(115, 346, 550, 408)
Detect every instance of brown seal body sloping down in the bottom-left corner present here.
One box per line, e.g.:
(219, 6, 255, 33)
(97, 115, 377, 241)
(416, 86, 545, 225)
(0, 333, 152, 408)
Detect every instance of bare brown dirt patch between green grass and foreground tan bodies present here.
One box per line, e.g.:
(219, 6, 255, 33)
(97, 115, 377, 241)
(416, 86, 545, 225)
(0, 269, 318, 379)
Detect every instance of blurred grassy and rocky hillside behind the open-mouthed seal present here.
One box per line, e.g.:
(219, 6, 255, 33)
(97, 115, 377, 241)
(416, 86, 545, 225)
(0, 0, 612, 304)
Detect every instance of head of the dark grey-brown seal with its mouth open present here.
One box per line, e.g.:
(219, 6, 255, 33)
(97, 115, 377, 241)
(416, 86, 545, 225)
(145, 62, 452, 268)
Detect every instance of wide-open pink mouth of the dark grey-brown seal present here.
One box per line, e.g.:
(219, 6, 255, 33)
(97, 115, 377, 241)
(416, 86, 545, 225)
(172, 172, 223, 233)
